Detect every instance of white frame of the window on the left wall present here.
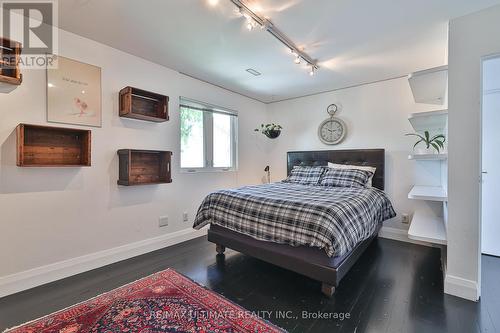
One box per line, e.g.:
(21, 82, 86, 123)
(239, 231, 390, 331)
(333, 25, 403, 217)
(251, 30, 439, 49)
(179, 97, 238, 173)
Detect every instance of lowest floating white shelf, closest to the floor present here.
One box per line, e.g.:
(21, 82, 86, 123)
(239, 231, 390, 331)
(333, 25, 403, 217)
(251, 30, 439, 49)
(408, 211, 446, 245)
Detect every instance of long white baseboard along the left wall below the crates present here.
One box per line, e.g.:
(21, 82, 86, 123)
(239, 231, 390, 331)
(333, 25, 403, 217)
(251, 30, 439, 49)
(0, 229, 207, 297)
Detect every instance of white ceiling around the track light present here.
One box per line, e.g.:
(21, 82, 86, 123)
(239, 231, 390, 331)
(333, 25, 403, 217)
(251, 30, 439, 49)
(59, 0, 500, 103)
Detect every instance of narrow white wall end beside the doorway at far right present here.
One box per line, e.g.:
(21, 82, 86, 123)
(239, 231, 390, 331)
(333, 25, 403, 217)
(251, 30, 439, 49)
(445, 6, 500, 300)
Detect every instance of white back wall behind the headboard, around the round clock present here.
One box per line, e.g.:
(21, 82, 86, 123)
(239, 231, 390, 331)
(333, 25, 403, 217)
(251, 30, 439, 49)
(269, 78, 445, 229)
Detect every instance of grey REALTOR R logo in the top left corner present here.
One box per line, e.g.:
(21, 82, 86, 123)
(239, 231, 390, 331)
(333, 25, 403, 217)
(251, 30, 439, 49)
(0, 0, 58, 68)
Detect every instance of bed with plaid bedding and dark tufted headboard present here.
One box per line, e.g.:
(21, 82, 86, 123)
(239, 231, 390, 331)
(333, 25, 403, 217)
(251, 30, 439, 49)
(193, 149, 395, 296)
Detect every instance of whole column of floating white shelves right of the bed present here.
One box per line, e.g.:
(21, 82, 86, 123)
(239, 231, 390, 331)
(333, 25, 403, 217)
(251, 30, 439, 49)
(408, 70, 448, 246)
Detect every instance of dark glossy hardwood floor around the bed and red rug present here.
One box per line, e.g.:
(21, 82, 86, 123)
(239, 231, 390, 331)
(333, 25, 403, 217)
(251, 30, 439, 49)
(0, 238, 500, 333)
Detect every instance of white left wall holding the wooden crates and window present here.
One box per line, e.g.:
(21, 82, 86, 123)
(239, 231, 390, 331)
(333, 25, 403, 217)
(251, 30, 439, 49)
(0, 31, 267, 284)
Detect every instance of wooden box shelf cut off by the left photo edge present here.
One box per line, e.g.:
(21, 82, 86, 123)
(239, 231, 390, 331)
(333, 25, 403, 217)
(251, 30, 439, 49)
(0, 38, 23, 93)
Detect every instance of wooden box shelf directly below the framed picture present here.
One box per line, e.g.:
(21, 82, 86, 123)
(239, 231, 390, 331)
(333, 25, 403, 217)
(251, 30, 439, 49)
(16, 124, 91, 167)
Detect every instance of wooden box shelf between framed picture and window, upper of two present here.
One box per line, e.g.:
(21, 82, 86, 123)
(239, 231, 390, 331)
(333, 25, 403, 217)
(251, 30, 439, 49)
(120, 87, 168, 123)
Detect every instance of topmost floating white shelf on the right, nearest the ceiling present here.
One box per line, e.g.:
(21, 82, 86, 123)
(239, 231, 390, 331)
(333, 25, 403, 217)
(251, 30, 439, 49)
(408, 66, 448, 105)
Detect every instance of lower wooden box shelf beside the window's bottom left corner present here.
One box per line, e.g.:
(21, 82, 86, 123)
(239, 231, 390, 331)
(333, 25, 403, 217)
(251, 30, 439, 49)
(118, 149, 172, 186)
